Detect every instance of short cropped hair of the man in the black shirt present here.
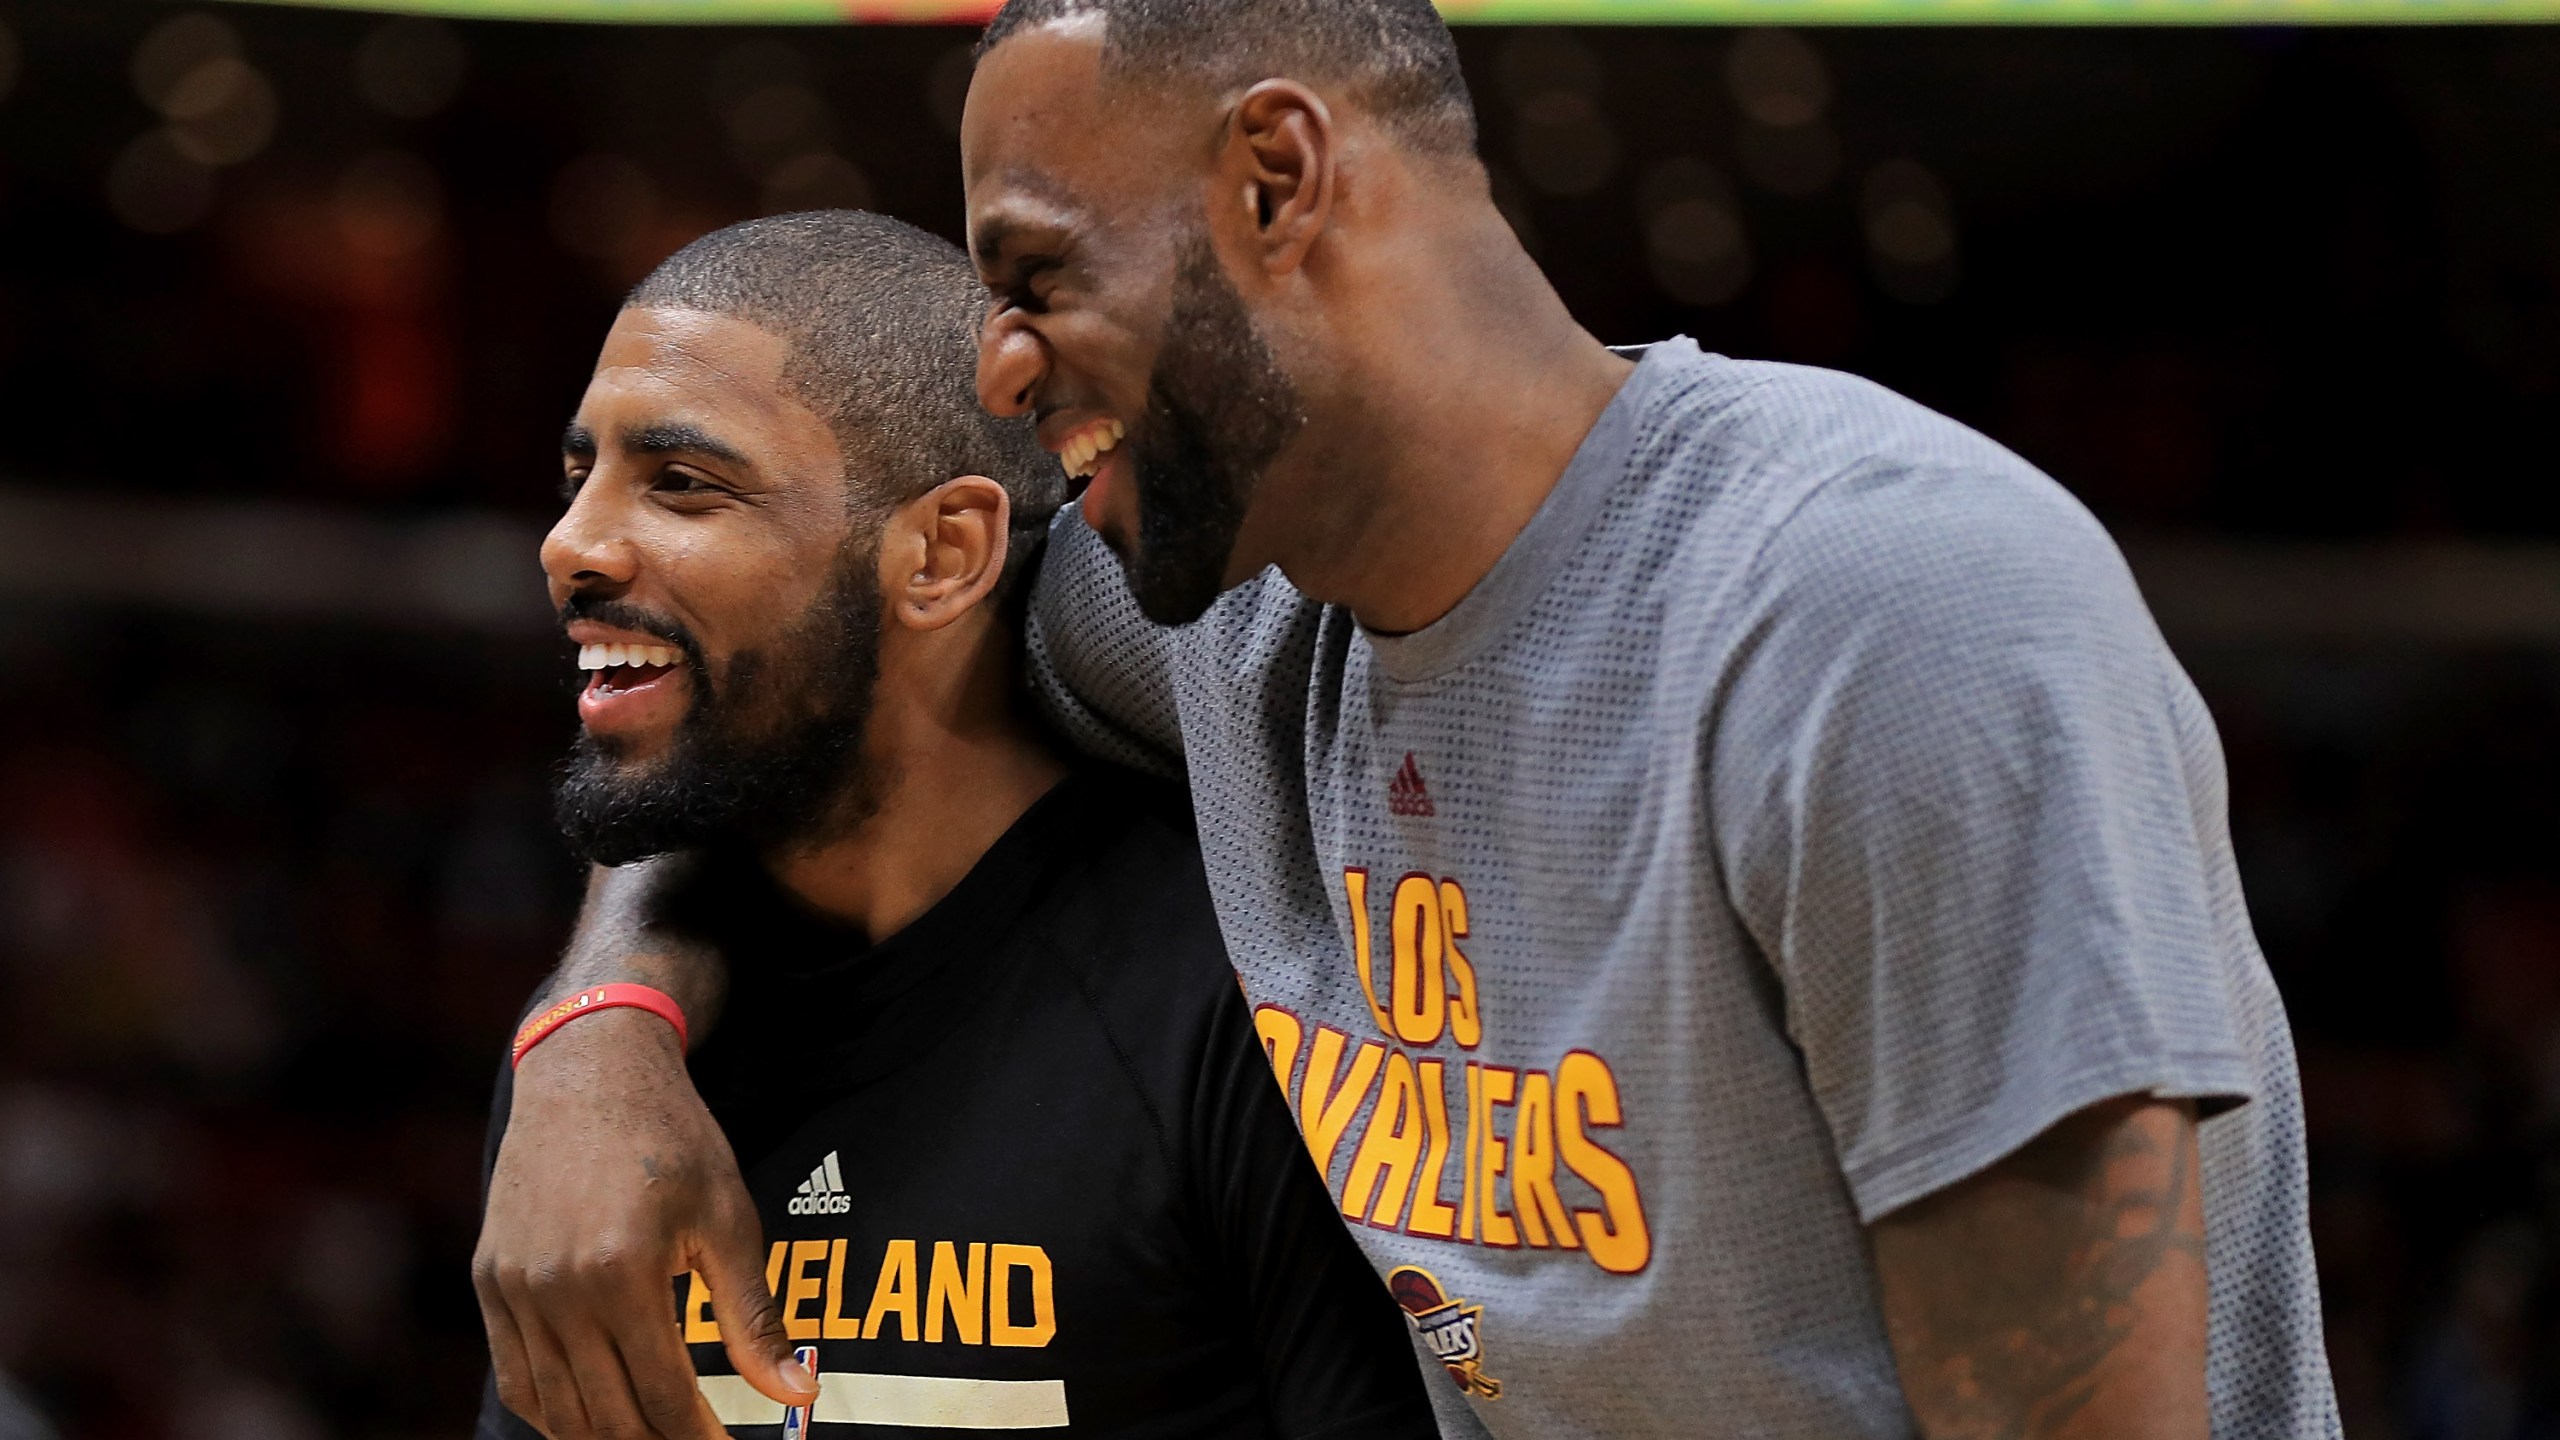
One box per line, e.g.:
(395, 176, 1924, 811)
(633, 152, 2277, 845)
(622, 210, 1068, 592)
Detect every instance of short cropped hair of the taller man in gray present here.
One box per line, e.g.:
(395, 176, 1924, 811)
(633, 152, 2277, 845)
(978, 0, 1475, 159)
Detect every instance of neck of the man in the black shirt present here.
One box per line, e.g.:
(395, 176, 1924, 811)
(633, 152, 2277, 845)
(771, 618, 1068, 943)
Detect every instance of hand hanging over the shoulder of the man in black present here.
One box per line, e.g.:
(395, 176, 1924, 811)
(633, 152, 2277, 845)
(471, 1010, 817, 1440)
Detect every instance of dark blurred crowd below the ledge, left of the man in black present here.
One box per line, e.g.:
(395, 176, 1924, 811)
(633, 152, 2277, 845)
(0, 607, 573, 1440)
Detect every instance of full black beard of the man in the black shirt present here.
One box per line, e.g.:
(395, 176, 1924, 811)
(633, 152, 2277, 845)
(553, 559, 881, 866)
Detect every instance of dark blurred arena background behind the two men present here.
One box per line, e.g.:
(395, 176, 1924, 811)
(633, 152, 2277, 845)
(0, 0, 2560, 1440)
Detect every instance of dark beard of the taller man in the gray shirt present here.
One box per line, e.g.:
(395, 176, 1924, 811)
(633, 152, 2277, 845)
(1121, 228, 1306, 625)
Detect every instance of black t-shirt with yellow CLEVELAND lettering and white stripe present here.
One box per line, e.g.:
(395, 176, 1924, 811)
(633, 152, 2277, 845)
(481, 771, 1436, 1440)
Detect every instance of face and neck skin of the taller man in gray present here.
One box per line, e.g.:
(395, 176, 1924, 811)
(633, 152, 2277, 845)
(960, 13, 1633, 633)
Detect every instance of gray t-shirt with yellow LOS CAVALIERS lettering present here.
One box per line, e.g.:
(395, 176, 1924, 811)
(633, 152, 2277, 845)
(1032, 341, 2337, 1437)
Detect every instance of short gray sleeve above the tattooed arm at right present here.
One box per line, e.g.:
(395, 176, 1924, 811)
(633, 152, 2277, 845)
(1705, 446, 2253, 1222)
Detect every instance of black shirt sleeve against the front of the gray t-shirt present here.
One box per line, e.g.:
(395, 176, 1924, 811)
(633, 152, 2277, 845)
(1190, 992, 1439, 1440)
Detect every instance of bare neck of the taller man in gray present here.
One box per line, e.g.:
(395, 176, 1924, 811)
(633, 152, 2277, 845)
(1280, 200, 1633, 633)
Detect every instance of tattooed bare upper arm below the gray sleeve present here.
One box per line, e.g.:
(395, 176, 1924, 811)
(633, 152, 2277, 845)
(1869, 1097, 2207, 1440)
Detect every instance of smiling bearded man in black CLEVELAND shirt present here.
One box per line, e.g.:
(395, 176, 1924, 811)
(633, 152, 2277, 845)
(476, 213, 1434, 1440)
